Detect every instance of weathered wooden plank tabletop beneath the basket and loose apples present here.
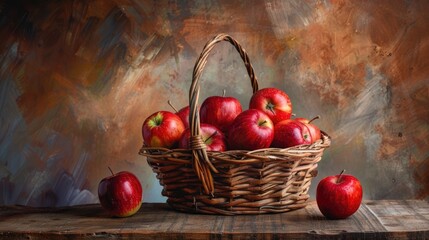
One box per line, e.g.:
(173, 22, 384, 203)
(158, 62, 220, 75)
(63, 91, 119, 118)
(0, 200, 429, 239)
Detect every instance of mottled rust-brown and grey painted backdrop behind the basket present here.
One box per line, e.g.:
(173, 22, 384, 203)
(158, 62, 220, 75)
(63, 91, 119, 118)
(0, 0, 429, 206)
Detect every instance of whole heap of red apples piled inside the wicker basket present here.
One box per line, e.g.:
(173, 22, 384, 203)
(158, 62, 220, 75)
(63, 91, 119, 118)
(142, 88, 321, 151)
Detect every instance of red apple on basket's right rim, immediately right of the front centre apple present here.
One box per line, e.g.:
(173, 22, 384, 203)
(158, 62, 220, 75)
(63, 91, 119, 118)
(271, 119, 311, 148)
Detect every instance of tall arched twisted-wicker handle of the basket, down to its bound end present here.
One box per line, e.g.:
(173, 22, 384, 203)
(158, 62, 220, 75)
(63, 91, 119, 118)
(189, 33, 258, 195)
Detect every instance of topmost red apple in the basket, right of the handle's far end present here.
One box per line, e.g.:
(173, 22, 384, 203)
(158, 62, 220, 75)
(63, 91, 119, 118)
(249, 88, 292, 124)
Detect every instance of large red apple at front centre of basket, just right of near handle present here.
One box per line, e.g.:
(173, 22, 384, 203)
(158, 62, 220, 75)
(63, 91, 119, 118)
(228, 109, 274, 150)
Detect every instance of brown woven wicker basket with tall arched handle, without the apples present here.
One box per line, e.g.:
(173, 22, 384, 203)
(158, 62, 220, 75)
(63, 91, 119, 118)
(139, 34, 331, 215)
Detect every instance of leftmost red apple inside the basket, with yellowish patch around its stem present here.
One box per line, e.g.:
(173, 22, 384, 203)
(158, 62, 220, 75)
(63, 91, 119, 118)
(142, 111, 185, 148)
